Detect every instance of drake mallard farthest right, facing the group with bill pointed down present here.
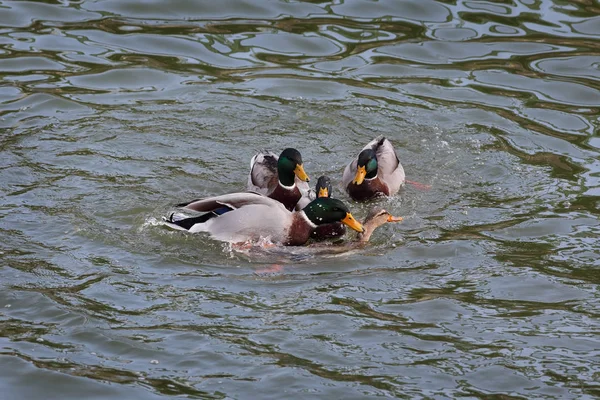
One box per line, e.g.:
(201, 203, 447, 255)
(342, 136, 405, 201)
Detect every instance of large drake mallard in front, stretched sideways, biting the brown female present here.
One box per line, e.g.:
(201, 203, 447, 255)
(165, 193, 363, 246)
